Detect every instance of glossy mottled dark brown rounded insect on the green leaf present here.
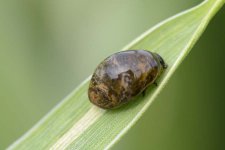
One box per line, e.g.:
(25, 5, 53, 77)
(88, 50, 166, 109)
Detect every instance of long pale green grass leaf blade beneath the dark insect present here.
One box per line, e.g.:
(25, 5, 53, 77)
(9, 0, 225, 149)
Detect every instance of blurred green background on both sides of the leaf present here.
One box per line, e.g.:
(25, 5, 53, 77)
(0, 0, 225, 150)
